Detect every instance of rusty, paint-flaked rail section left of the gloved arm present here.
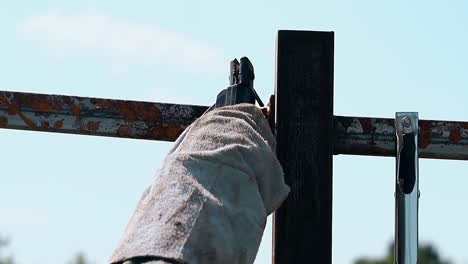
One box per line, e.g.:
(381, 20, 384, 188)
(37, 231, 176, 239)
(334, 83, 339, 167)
(0, 91, 207, 141)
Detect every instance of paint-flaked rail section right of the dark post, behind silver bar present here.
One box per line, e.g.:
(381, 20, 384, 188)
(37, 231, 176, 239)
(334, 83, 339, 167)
(334, 116, 468, 160)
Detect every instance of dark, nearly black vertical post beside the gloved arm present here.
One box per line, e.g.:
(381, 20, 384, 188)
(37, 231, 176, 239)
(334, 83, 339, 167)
(273, 31, 334, 264)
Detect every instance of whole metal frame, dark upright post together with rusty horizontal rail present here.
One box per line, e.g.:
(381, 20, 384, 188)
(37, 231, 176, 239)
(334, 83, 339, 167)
(0, 31, 468, 264)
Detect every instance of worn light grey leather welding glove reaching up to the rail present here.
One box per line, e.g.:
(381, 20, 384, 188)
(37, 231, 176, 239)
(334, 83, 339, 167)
(110, 104, 289, 264)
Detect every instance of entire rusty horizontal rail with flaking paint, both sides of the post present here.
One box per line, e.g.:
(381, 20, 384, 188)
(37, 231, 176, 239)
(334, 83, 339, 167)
(0, 91, 468, 160)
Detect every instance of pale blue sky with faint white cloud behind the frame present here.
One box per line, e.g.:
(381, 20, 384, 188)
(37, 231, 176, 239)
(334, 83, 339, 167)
(0, 0, 468, 264)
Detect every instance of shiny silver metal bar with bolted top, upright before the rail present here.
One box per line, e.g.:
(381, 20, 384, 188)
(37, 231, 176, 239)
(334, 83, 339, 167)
(395, 112, 419, 264)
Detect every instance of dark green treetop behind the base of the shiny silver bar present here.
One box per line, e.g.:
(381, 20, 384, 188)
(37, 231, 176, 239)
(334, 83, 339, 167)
(354, 244, 451, 264)
